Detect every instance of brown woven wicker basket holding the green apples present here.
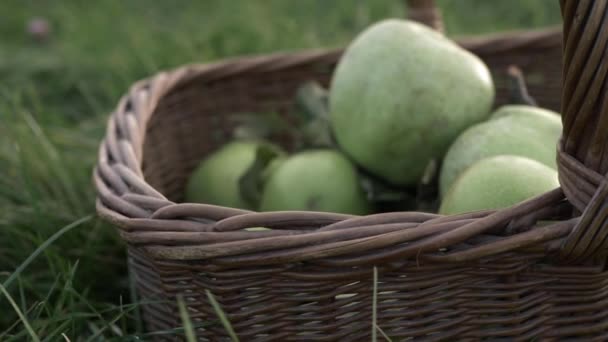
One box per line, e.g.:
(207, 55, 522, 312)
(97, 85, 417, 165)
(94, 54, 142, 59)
(94, 0, 608, 341)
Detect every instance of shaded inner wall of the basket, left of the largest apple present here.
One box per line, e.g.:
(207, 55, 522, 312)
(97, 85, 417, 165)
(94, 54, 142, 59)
(143, 58, 339, 202)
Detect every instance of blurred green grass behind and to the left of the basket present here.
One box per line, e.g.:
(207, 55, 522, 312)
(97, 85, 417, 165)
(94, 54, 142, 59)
(0, 0, 560, 341)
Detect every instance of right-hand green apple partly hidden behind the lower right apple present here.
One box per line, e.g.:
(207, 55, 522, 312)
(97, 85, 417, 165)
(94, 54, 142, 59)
(439, 105, 562, 197)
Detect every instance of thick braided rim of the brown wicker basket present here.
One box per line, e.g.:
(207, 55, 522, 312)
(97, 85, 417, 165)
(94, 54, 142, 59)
(93, 24, 575, 265)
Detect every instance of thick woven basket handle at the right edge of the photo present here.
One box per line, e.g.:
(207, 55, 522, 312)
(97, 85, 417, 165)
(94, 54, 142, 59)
(558, 0, 608, 263)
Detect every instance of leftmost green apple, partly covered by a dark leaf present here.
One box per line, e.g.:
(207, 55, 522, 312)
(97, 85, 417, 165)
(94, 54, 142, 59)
(185, 140, 284, 210)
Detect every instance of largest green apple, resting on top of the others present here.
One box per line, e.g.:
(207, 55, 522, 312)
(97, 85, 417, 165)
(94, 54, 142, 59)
(329, 19, 494, 185)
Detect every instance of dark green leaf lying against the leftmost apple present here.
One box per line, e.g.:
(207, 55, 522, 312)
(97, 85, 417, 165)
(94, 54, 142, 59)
(239, 144, 282, 208)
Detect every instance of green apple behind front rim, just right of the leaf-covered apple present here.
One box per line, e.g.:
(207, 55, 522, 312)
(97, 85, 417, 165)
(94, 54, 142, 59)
(260, 149, 370, 214)
